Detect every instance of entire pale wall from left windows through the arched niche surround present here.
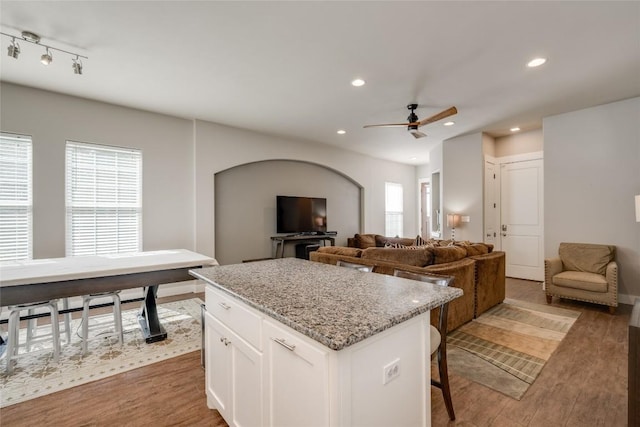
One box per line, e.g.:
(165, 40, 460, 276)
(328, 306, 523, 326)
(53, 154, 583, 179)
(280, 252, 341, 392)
(0, 82, 417, 266)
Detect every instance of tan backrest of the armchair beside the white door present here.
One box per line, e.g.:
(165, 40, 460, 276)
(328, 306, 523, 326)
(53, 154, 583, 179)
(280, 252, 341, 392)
(558, 243, 616, 275)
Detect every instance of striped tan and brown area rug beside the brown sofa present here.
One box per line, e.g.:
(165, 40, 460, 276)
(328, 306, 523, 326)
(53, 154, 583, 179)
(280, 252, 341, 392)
(447, 299, 580, 400)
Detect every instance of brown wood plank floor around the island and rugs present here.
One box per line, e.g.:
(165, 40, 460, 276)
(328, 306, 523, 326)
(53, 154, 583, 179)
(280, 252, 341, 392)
(0, 279, 631, 427)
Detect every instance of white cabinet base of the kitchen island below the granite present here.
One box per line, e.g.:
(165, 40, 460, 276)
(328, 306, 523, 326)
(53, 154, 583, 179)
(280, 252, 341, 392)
(205, 285, 431, 427)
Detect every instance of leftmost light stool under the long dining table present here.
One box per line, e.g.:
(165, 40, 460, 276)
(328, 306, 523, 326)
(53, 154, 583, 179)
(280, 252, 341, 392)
(6, 299, 61, 374)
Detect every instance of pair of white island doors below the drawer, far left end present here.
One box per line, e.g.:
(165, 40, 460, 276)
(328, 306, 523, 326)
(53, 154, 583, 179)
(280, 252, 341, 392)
(205, 312, 264, 427)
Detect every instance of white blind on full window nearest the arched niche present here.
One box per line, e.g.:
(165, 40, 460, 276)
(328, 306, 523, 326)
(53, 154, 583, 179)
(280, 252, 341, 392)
(66, 141, 142, 256)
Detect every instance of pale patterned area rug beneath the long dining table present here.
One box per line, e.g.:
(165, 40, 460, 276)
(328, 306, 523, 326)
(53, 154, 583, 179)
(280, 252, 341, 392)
(0, 298, 202, 407)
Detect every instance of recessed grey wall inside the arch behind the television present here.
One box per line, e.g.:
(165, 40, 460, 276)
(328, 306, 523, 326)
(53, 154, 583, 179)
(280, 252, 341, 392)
(215, 160, 361, 264)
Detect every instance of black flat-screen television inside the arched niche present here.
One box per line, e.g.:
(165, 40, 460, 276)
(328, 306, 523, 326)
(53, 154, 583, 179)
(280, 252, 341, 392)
(276, 196, 327, 234)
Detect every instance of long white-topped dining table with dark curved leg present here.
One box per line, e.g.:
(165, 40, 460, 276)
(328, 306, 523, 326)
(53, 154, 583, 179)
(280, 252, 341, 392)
(0, 249, 217, 343)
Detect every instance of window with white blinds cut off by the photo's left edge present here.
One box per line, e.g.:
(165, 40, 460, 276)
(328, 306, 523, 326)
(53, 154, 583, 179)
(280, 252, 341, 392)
(0, 133, 33, 261)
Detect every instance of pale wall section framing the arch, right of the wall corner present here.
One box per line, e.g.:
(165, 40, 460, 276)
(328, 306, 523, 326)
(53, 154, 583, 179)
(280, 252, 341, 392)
(195, 120, 417, 256)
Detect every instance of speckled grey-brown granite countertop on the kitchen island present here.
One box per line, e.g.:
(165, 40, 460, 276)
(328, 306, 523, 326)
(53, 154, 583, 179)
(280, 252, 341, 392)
(190, 258, 462, 350)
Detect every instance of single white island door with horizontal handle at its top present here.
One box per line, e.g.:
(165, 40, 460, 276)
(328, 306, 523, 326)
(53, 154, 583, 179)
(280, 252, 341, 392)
(263, 321, 329, 427)
